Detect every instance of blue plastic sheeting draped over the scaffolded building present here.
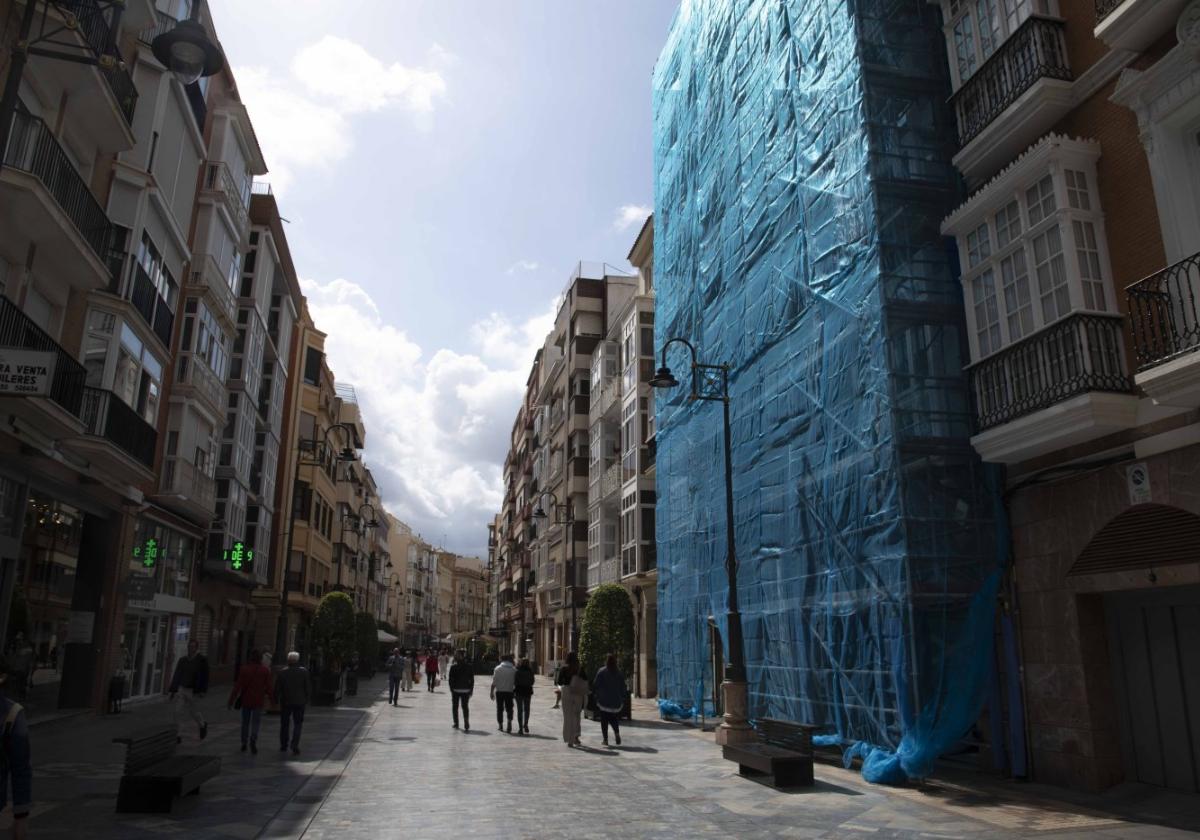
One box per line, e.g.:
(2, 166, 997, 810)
(654, 0, 1002, 782)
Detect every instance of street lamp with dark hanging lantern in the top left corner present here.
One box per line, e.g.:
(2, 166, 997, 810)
(0, 0, 224, 175)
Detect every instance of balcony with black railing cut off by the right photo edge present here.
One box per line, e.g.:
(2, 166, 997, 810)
(1126, 249, 1200, 408)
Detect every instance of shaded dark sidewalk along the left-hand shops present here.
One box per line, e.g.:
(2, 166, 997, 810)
(0, 676, 386, 840)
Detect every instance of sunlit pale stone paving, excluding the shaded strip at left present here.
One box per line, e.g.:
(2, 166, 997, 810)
(288, 678, 1200, 840)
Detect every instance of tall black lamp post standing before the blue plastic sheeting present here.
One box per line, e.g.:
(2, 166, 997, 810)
(650, 337, 754, 745)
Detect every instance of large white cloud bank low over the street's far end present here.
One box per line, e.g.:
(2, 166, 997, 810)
(302, 278, 557, 561)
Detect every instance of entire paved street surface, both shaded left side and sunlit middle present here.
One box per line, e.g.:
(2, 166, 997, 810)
(9, 678, 1200, 840)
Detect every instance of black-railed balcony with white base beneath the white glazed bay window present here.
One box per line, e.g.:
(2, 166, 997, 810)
(968, 313, 1138, 463)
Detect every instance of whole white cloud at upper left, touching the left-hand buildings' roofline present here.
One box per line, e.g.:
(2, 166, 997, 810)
(236, 35, 446, 193)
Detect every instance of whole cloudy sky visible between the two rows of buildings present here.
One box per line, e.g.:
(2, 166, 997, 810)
(209, 0, 678, 557)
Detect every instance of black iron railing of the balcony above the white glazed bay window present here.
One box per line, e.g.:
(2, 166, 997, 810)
(950, 16, 1072, 146)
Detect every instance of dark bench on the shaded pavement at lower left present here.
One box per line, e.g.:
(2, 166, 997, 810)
(113, 726, 221, 814)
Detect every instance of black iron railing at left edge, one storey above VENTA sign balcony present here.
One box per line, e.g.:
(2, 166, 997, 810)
(4, 109, 115, 265)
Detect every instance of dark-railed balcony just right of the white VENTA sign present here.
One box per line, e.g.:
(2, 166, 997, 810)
(71, 386, 158, 475)
